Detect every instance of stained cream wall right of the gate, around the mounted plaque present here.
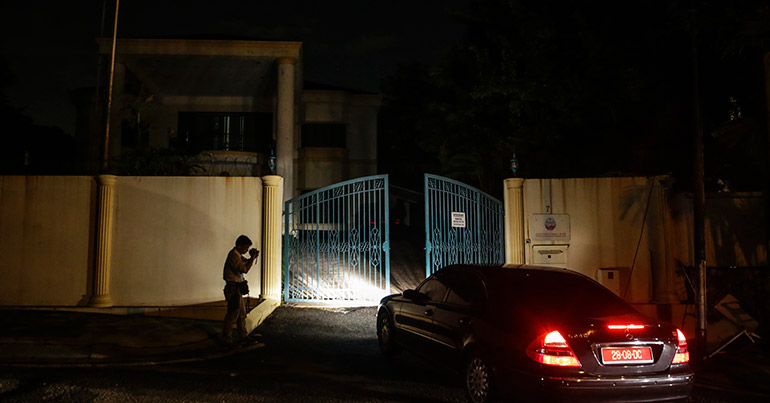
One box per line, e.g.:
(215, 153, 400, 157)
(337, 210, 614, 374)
(524, 177, 672, 303)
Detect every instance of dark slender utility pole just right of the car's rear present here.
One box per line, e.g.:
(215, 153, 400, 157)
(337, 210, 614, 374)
(689, 5, 707, 361)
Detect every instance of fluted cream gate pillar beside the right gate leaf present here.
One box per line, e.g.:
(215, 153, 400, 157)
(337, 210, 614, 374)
(503, 178, 524, 264)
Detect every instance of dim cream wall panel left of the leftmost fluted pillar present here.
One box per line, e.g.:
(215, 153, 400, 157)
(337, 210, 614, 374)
(0, 176, 96, 306)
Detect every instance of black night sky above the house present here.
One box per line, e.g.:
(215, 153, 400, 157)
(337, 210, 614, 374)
(0, 0, 467, 134)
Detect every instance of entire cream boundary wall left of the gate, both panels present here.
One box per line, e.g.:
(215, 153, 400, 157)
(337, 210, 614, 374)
(0, 176, 262, 306)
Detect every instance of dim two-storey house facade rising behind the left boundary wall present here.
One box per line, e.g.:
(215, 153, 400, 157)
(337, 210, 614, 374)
(73, 39, 380, 199)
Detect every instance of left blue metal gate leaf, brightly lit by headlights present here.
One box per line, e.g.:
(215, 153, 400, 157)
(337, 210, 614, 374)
(283, 175, 390, 302)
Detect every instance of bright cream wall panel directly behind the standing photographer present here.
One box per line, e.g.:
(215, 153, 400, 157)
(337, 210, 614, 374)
(110, 177, 262, 306)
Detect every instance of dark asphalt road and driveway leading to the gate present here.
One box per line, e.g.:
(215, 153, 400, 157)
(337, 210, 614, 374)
(0, 306, 766, 402)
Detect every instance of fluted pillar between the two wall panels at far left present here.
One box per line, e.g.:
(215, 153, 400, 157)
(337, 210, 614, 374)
(88, 175, 117, 308)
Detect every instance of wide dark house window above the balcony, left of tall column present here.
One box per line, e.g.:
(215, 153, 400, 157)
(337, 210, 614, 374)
(177, 112, 273, 154)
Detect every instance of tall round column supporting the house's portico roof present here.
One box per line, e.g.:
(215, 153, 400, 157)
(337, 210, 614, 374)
(275, 57, 297, 204)
